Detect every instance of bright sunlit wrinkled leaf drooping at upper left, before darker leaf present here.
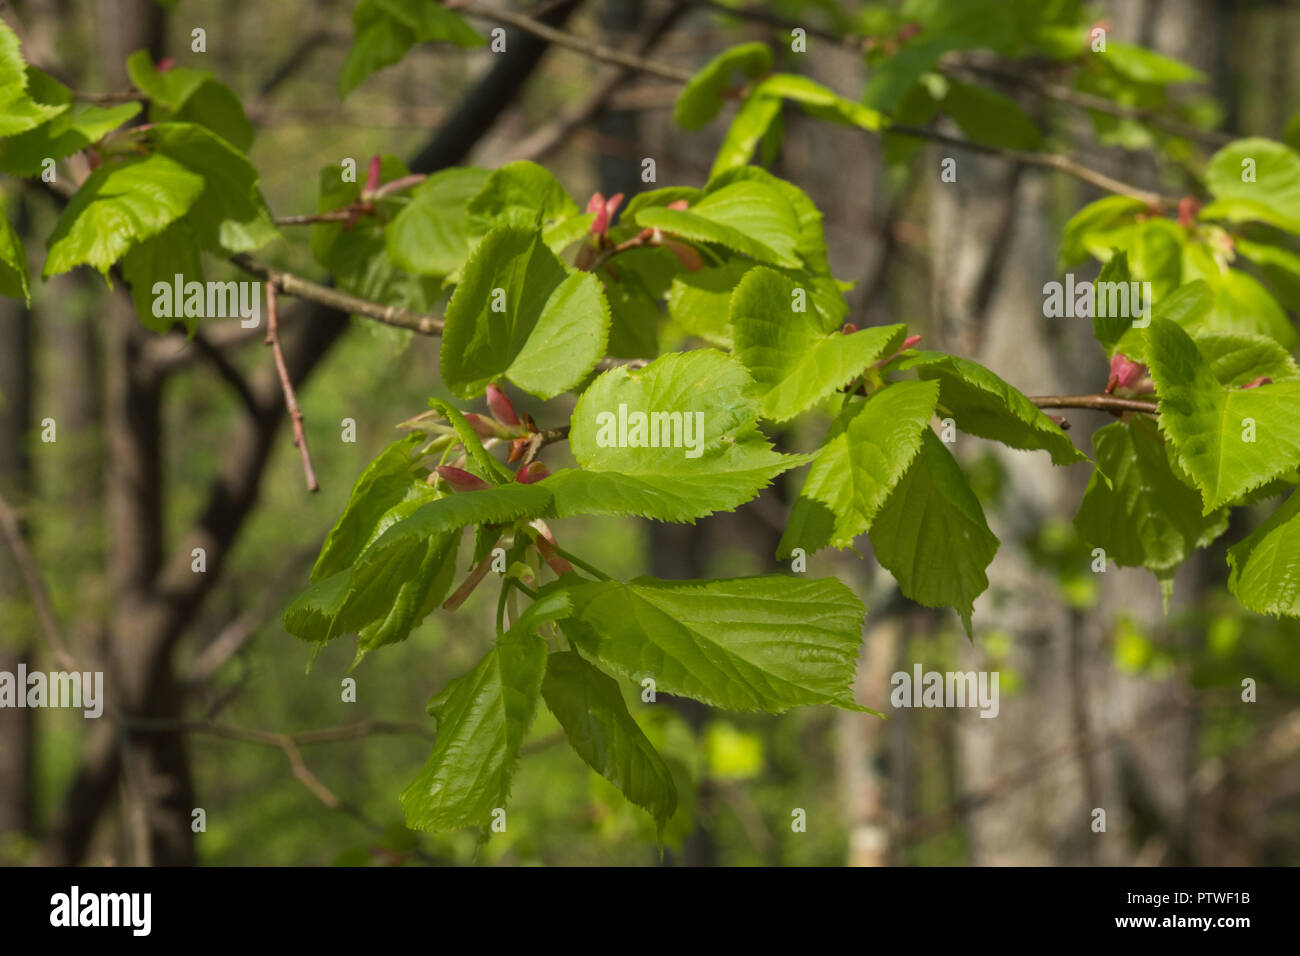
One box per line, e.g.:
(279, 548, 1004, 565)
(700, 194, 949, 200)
(43, 155, 204, 277)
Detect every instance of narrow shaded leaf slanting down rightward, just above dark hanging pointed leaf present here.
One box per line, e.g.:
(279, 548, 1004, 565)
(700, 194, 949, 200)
(894, 351, 1088, 464)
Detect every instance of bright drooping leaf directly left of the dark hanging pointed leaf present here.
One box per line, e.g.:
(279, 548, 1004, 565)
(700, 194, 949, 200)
(776, 382, 939, 558)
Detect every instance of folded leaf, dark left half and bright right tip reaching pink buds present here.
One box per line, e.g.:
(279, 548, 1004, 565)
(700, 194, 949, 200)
(731, 267, 907, 421)
